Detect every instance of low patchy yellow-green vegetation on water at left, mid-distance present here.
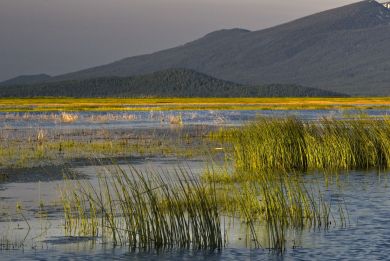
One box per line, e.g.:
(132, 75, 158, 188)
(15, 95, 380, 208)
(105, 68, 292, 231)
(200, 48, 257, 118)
(0, 127, 212, 169)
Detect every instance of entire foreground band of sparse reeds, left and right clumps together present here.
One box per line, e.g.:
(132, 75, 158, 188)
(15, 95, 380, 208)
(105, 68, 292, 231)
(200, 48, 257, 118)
(63, 162, 342, 251)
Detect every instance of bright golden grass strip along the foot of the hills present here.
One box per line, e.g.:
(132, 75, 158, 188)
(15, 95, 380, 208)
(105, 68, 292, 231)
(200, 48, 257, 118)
(0, 97, 390, 112)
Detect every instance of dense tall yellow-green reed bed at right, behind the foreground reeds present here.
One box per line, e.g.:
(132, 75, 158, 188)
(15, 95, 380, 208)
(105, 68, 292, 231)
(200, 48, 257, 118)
(217, 117, 390, 171)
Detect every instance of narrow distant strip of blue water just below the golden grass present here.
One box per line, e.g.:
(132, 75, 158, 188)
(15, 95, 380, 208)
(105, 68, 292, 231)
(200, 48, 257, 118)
(0, 109, 389, 129)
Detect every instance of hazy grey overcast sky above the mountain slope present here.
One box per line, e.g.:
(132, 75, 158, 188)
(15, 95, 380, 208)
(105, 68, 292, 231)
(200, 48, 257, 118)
(0, 0, 356, 80)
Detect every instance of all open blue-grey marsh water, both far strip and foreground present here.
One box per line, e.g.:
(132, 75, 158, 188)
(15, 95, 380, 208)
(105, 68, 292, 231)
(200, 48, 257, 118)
(0, 110, 390, 260)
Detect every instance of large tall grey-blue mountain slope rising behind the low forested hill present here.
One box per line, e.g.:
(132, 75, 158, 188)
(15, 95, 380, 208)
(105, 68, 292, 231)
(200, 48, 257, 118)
(45, 1, 390, 95)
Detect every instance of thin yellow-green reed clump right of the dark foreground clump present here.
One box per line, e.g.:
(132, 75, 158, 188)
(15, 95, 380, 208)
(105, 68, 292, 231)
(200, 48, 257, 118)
(206, 168, 338, 251)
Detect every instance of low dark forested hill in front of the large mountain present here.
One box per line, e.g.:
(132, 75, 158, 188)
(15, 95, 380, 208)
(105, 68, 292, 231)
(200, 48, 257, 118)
(0, 69, 344, 97)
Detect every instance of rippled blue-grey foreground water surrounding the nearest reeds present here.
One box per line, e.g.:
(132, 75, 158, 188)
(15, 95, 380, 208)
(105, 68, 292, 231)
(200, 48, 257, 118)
(0, 166, 390, 260)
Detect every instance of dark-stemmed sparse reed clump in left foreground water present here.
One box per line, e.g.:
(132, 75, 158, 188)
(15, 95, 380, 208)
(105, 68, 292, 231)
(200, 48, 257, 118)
(63, 168, 223, 249)
